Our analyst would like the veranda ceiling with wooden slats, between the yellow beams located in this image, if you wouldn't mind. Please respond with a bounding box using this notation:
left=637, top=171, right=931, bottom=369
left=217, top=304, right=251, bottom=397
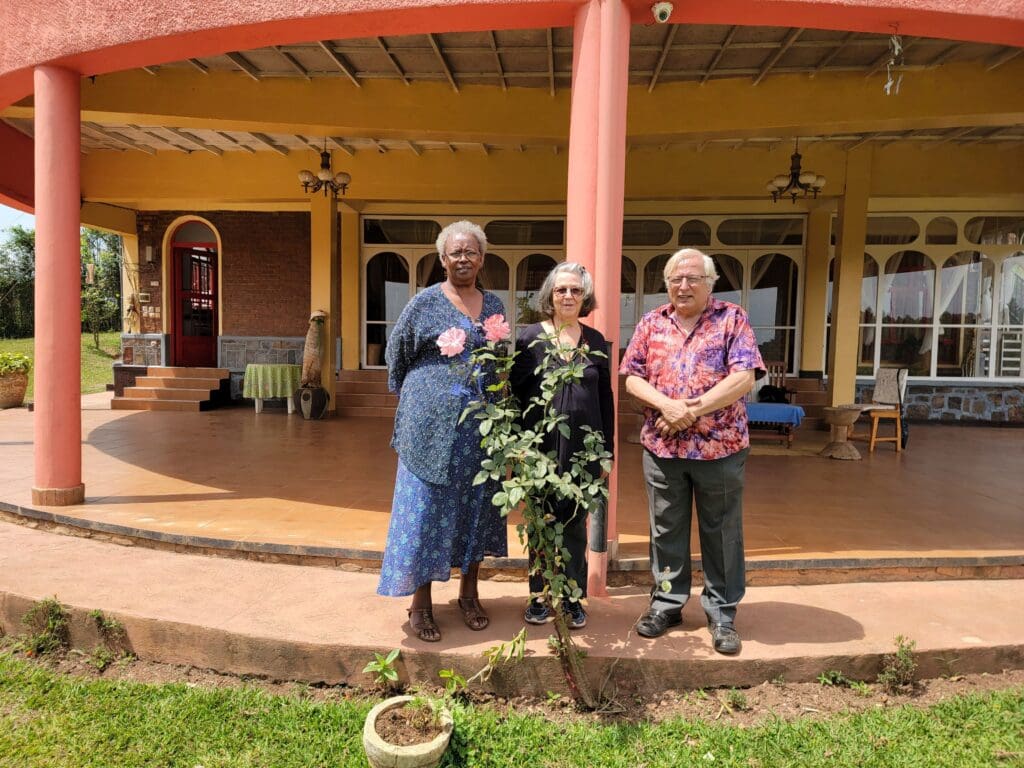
left=3, top=25, right=1024, bottom=156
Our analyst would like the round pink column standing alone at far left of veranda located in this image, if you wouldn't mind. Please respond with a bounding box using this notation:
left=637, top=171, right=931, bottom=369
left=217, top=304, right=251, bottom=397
left=32, top=67, right=85, bottom=505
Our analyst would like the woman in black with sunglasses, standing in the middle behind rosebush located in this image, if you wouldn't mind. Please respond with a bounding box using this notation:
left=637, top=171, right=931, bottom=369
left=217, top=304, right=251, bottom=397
left=511, top=261, right=615, bottom=629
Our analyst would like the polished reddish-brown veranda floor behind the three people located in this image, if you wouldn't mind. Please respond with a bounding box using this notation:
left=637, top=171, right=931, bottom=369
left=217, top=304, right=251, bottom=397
left=0, top=395, right=1024, bottom=563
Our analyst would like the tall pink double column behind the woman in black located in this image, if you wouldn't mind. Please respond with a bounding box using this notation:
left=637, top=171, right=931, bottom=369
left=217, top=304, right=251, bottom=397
left=566, top=0, right=630, bottom=597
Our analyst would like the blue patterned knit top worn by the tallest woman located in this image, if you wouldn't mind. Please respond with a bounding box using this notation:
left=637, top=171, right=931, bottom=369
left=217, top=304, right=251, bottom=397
left=384, top=285, right=505, bottom=484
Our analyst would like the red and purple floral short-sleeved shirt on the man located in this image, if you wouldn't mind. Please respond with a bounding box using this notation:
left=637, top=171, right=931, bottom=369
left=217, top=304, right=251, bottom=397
left=618, top=296, right=765, bottom=459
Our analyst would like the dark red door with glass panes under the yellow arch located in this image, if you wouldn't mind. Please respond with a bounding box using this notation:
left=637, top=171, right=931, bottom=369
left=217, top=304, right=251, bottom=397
left=172, top=244, right=217, bottom=368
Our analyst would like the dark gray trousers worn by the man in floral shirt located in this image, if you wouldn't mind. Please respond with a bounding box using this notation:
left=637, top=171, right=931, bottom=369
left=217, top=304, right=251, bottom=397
left=643, top=449, right=750, bottom=624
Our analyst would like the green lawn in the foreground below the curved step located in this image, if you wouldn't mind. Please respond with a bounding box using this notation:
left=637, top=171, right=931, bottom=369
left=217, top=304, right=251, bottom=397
left=0, top=653, right=1024, bottom=768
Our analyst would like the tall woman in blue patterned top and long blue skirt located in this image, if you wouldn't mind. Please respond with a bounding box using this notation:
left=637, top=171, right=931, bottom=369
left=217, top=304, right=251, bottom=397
left=377, top=221, right=508, bottom=642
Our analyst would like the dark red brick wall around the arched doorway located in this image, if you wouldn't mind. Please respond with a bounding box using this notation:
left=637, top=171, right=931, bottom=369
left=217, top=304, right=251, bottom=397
left=137, top=211, right=310, bottom=337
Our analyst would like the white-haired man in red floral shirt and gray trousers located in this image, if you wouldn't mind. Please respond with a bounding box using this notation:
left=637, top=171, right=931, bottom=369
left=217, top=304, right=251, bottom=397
left=620, top=249, right=764, bottom=653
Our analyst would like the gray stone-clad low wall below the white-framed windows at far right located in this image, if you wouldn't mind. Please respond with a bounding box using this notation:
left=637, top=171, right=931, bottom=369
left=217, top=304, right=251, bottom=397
left=857, top=382, right=1024, bottom=426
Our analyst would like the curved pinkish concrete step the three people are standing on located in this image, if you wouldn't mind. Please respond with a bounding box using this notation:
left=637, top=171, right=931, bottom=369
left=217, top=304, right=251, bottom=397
left=0, top=523, right=1024, bottom=697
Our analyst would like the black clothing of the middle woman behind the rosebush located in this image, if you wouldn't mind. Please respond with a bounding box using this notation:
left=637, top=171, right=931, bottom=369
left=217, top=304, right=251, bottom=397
left=510, top=323, right=615, bottom=596
